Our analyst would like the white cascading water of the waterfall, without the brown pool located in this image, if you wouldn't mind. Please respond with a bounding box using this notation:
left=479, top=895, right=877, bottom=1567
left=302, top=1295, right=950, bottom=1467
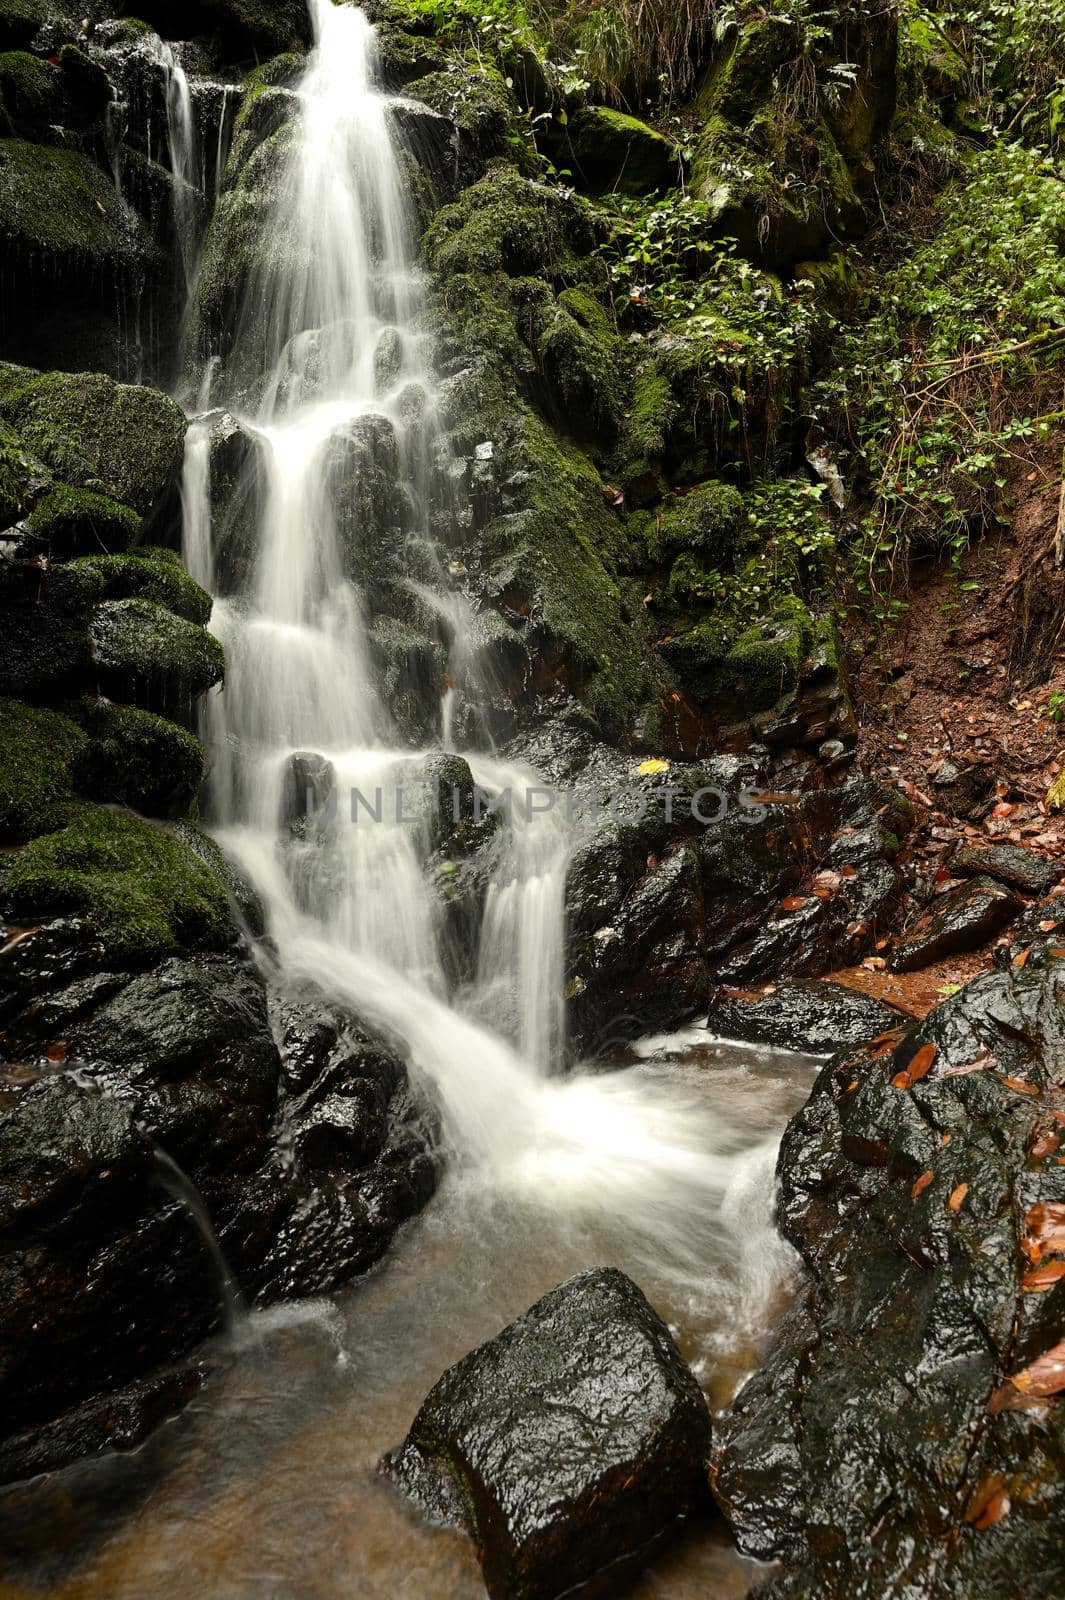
left=185, top=0, right=793, bottom=1376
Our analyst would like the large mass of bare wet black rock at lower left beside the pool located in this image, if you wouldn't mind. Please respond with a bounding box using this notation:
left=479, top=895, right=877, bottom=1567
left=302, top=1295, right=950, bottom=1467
left=0, top=918, right=437, bottom=1478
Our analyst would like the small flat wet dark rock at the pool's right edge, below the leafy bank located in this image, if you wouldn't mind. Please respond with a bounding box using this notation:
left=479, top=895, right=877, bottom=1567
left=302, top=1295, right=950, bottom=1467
left=708, top=982, right=913, bottom=1056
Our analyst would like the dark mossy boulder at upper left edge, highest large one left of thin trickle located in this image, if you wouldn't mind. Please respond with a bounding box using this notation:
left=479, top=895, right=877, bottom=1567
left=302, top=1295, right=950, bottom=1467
left=0, top=139, right=150, bottom=280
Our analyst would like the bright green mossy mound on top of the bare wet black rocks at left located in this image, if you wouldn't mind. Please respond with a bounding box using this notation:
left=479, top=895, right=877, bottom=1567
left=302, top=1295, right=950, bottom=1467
left=0, top=808, right=233, bottom=962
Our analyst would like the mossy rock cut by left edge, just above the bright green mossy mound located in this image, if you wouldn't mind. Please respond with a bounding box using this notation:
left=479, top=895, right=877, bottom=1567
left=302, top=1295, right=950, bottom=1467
left=0, top=699, right=86, bottom=845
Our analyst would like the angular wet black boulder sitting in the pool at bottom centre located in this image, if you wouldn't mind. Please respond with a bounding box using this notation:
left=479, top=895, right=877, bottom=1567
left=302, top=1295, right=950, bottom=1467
left=382, top=1269, right=710, bottom=1600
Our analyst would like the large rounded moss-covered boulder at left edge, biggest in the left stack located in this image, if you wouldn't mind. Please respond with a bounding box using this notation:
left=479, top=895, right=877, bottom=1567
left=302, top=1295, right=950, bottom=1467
left=0, top=363, right=187, bottom=515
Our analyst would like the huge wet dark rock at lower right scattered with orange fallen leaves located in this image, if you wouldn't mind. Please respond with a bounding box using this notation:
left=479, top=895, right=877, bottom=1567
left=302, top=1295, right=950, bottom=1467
left=712, top=960, right=1065, bottom=1600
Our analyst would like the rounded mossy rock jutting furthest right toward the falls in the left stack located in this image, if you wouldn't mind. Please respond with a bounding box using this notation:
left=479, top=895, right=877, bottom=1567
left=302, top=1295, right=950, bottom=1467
left=90, top=597, right=225, bottom=715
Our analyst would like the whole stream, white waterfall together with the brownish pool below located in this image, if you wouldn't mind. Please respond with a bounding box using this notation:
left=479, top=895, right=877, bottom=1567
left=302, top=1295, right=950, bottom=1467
left=3, top=0, right=811, bottom=1600
